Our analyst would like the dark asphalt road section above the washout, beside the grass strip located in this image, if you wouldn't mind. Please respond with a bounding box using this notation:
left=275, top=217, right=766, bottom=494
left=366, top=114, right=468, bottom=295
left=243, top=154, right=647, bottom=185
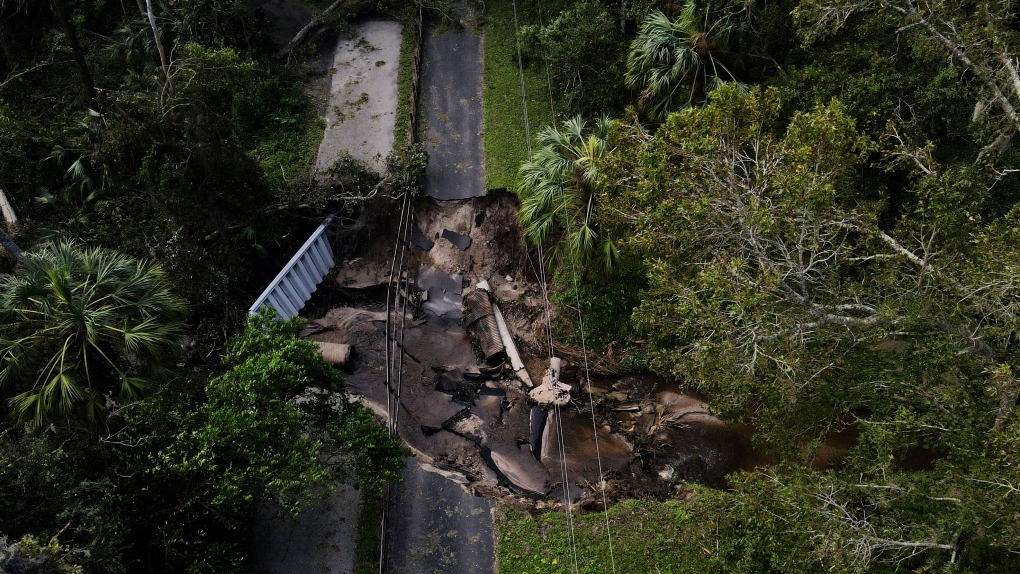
left=421, top=31, right=486, bottom=200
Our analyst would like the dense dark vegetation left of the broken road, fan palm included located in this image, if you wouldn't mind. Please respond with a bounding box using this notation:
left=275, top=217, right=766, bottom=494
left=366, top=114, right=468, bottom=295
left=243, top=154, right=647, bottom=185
left=0, top=0, right=408, bottom=572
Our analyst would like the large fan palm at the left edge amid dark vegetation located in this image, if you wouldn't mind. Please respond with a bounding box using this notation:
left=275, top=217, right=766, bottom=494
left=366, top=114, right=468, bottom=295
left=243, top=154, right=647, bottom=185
left=0, top=241, right=184, bottom=425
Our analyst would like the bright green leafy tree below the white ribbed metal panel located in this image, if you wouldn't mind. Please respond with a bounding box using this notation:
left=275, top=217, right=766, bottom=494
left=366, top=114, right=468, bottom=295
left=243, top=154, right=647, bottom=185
left=117, top=315, right=403, bottom=572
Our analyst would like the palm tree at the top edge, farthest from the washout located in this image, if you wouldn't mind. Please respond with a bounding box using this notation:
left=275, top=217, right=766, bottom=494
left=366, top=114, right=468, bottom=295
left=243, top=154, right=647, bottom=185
left=625, top=0, right=749, bottom=121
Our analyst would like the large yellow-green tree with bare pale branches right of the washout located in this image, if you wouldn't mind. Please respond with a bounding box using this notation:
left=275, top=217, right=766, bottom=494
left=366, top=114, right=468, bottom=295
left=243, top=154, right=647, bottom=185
left=597, top=87, right=1020, bottom=572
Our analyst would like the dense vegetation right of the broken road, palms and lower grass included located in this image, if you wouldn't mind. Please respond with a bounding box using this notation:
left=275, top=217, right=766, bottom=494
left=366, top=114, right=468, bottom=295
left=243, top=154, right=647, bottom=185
left=500, top=0, right=1020, bottom=573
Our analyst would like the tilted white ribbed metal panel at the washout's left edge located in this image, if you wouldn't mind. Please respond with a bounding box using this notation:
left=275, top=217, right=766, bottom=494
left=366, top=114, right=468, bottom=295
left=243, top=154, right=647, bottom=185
left=248, top=215, right=334, bottom=320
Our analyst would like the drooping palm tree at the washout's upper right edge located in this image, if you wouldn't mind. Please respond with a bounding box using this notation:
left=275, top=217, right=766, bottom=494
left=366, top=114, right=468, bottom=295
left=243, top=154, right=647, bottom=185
left=517, top=115, right=618, bottom=271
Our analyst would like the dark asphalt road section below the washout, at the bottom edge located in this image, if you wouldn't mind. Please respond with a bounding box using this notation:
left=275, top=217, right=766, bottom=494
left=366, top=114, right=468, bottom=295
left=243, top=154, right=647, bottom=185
left=388, top=459, right=496, bottom=574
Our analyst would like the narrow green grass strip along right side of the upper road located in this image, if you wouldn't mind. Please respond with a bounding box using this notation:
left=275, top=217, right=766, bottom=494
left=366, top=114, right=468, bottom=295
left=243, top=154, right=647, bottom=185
left=482, top=0, right=554, bottom=190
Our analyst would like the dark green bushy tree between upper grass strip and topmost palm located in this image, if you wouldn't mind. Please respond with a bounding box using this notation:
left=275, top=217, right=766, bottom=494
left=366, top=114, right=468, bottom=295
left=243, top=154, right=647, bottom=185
left=520, top=2, right=626, bottom=117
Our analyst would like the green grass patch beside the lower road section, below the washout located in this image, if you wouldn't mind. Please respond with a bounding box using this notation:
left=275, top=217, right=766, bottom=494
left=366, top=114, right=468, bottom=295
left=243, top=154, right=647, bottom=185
left=496, top=501, right=715, bottom=574
